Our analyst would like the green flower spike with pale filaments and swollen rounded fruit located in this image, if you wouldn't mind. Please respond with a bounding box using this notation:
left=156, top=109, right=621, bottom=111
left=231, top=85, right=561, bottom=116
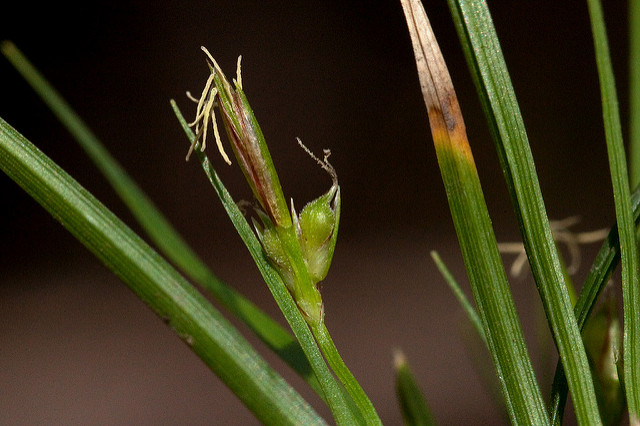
left=187, top=47, right=340, bottom=325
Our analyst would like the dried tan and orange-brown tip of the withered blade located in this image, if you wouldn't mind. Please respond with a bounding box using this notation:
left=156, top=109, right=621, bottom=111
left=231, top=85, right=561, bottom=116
left=401, top=0, right=473, bottom=163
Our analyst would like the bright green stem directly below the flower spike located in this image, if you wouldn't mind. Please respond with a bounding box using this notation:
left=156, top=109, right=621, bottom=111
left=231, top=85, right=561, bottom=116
left=312, top=322, right=382, bottom=425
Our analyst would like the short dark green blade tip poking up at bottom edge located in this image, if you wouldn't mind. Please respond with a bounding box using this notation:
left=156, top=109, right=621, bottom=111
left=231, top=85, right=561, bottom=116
left=393, top=351, right=436, bottom=426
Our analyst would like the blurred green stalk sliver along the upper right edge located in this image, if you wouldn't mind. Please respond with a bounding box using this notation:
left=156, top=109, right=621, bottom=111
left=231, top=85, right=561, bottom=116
left=629, top=0, right=640, bottom=188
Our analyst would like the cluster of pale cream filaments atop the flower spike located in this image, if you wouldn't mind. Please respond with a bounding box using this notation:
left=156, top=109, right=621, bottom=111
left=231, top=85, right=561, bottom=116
left=186, top=46, right=242, bottom=164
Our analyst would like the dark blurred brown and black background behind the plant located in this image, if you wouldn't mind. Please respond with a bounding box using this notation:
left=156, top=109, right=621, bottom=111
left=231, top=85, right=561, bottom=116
left=0, top=0, right=627, bottom=425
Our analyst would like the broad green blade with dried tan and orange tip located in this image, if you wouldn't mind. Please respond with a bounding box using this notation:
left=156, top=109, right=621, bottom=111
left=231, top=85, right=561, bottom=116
left=402, top=0, right=549, bottom=425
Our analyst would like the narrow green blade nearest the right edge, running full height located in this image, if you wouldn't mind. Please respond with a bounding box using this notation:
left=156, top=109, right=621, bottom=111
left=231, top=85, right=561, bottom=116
left=587, top=0, right=640, bottom=423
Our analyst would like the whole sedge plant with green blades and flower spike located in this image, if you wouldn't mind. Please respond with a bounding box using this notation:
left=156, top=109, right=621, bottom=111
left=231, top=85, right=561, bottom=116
left=0, top=0, right=640, bottom=425
